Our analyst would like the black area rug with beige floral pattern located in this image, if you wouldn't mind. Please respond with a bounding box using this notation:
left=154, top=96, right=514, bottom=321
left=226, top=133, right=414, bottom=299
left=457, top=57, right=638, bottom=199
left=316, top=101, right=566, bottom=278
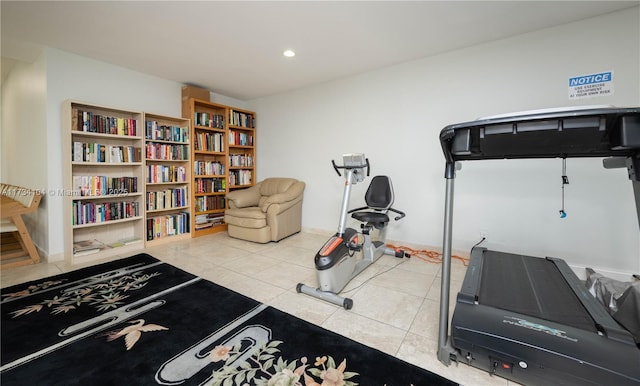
left=0, top=254, right=456, bottom=386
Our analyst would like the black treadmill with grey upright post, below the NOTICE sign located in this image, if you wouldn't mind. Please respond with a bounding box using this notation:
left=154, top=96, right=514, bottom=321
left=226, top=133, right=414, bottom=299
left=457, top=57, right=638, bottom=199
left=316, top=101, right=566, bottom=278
left=437, top=108, right=640, bottom=386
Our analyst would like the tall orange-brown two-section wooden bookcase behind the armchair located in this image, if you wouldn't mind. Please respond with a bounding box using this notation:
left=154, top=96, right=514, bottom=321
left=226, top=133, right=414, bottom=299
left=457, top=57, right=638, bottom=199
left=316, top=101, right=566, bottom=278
left=182, top=98, right=256, bottom=237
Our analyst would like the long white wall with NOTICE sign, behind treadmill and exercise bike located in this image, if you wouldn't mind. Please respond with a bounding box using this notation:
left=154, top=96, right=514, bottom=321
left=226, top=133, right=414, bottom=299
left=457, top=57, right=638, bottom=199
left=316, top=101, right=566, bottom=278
left=249, top=8, right=640, bottom=272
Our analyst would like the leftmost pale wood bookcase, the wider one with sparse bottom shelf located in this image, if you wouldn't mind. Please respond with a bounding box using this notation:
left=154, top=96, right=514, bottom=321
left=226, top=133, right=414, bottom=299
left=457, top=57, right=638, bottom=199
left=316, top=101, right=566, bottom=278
left=62, top=101, right=145, bottom=264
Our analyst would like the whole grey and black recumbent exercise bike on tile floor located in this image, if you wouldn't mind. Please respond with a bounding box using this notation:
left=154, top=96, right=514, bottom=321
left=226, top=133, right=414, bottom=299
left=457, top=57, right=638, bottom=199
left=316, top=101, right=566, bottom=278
left=296, top=154, right=409, bottom=310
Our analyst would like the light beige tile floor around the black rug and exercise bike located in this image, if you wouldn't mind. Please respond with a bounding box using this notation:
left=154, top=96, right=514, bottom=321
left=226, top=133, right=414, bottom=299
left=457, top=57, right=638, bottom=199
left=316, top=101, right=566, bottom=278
left=0, top=232, right=515, bottom=386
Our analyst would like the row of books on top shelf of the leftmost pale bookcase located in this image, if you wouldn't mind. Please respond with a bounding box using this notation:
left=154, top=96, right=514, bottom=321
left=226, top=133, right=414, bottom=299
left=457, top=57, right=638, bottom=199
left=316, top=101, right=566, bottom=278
left=71, top=109, right=138, bottom=137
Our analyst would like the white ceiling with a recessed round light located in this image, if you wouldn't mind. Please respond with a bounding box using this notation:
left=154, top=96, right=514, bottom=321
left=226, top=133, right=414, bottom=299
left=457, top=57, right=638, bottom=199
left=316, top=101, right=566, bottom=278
left=0, top=0, right=640, bottom=100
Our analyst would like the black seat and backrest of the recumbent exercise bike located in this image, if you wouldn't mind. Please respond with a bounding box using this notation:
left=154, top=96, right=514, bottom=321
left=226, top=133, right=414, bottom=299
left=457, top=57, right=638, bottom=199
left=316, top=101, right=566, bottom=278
left=349, top=176, right=394, bottom=229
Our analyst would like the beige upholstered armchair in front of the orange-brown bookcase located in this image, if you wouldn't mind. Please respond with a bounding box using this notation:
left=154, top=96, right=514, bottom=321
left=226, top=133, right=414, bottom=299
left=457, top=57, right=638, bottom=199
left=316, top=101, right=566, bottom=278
left=224, top=178, right=305, bottom=243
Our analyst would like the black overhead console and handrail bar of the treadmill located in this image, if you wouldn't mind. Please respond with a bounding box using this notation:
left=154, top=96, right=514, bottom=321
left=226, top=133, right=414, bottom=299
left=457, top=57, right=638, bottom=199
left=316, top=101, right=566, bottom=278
left=440, top=107, right=640, bottom=164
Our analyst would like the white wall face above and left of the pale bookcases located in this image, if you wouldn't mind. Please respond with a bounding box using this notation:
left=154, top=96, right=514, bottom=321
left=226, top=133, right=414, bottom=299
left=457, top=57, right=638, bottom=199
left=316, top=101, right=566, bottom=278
left=44, top=49, right=182, bottom=261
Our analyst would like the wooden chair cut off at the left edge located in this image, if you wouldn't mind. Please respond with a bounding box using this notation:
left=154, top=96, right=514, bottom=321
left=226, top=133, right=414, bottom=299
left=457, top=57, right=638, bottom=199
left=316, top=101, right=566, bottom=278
left=0, top=184, right=42, bottom=269
